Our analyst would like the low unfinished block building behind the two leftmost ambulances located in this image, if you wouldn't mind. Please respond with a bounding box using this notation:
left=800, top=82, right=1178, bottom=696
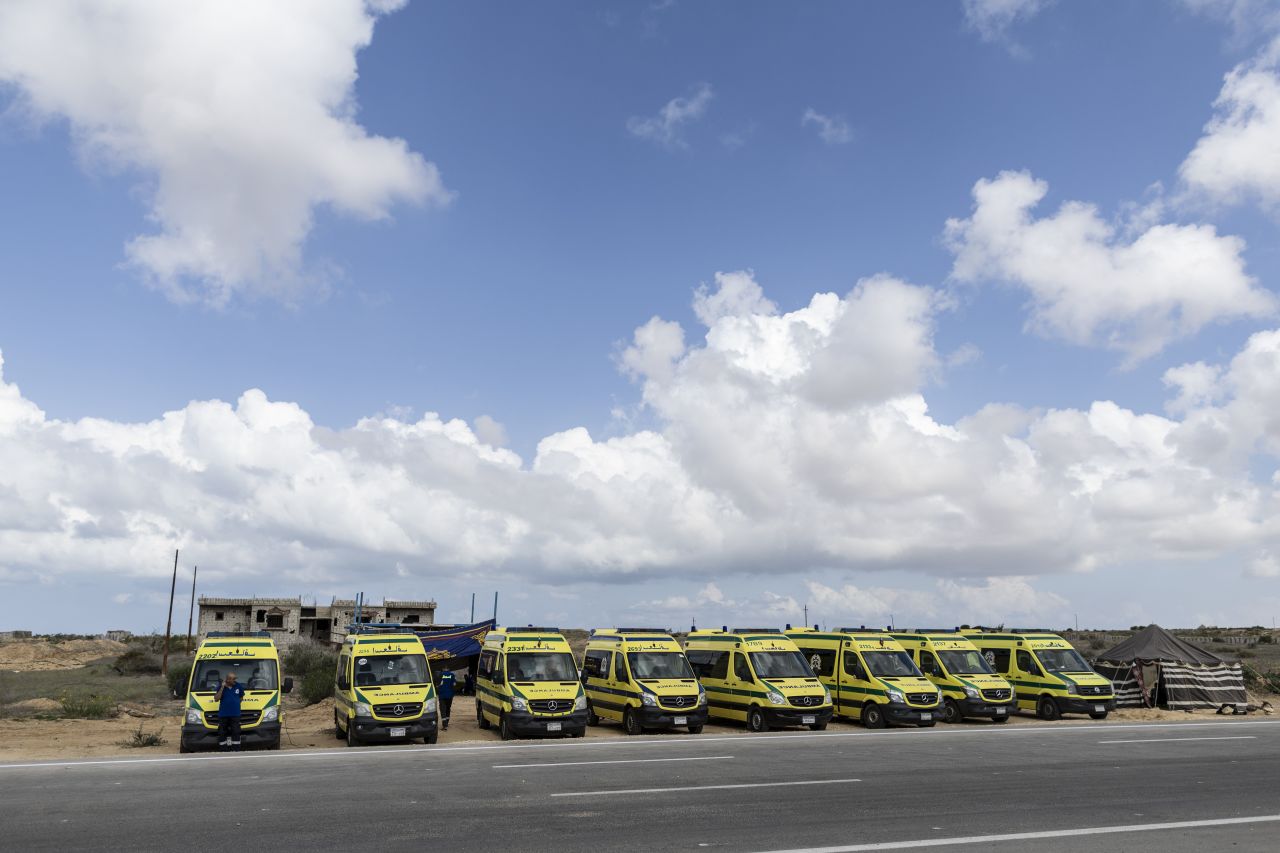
left=198, top=596, right=435, bottom=646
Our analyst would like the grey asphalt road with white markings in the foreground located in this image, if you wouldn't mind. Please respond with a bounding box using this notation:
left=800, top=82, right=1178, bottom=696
left=0, top=721, right=1280, bottom=853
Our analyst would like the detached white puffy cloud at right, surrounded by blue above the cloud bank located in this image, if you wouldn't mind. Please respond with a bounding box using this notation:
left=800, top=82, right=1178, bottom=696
left=946, top=172, right=1276, bottom=362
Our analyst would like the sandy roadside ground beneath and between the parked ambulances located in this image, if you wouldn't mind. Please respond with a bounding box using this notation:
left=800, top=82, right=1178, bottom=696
left=0, top=697, right=1275, bottom=763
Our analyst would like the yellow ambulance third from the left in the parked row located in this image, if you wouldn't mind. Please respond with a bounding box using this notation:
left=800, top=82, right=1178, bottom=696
left=476, top=626, right=586, bottom=740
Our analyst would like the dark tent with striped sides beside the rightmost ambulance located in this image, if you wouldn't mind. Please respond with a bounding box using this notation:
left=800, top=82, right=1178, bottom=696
left=1093, top=625, right=1248, bottom=711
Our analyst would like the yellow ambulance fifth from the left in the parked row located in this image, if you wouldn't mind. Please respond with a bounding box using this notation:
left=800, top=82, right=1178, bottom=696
left=685, top=628, right=832, bottom=731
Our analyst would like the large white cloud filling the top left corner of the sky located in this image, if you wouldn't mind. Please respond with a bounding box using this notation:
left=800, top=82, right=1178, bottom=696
left=0, top=0, right=451, bottom=305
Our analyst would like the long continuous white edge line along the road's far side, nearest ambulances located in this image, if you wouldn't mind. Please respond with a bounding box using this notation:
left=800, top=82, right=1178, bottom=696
left=0, top=720, right=1280, bottom=770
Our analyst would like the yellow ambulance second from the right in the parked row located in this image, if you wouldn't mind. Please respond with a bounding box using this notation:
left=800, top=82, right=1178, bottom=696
left=892, top=630, right=1014, bottom=722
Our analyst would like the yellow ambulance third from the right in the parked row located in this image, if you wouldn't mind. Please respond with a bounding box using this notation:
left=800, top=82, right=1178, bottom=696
left=787, top=628, right=942, bottom=729
